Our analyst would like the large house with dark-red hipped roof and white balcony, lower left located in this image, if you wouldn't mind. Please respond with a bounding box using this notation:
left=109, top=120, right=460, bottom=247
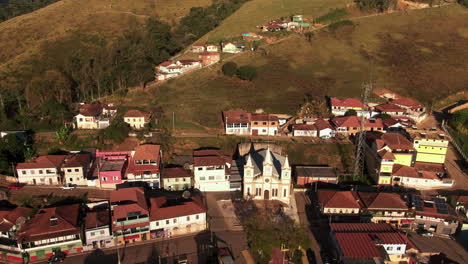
left=17, top=204, right=83, bottom=261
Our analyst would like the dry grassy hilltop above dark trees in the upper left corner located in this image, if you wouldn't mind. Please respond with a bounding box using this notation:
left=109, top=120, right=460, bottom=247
left=0, top=0, right=211, bottom=69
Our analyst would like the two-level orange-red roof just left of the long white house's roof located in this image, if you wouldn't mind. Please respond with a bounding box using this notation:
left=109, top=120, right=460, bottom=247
left=110, top=187, right=148, bottom=220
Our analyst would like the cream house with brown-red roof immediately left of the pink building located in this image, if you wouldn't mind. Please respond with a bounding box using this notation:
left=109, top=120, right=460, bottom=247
left=61, top=153, right=92, bottom=186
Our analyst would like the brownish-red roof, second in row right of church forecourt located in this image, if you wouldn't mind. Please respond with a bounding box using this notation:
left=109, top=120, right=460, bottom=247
left=358, top=192, right=408, bottom=211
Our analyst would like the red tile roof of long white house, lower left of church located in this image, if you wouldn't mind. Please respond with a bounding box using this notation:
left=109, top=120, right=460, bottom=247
left=150, top=196, right=206, bottom=221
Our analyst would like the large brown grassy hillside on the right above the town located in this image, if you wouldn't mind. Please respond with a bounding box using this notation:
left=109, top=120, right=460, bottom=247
left=134, top=5, right=468, bottom=128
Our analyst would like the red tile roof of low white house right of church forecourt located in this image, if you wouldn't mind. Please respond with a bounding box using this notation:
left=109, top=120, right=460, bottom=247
left=318, top=190, right=362, bottom=209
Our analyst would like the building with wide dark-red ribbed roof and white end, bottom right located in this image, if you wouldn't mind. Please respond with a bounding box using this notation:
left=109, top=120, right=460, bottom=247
left=330, top=223, right=411, bottom=264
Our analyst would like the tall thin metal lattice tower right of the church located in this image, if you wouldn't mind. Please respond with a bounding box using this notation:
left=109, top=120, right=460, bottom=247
left=353, top=83, right=372, bottom=180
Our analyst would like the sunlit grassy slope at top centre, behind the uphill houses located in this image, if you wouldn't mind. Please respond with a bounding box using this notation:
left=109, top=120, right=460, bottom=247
left=202, top=0, right=353, bottom=40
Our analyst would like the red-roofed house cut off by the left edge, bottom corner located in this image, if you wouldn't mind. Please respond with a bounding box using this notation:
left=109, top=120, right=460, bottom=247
left=0, top=207, right=32, bottom=263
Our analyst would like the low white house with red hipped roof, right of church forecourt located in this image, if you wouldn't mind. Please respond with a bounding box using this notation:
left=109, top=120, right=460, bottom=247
left=317, top=190, right=364, bottom=218
